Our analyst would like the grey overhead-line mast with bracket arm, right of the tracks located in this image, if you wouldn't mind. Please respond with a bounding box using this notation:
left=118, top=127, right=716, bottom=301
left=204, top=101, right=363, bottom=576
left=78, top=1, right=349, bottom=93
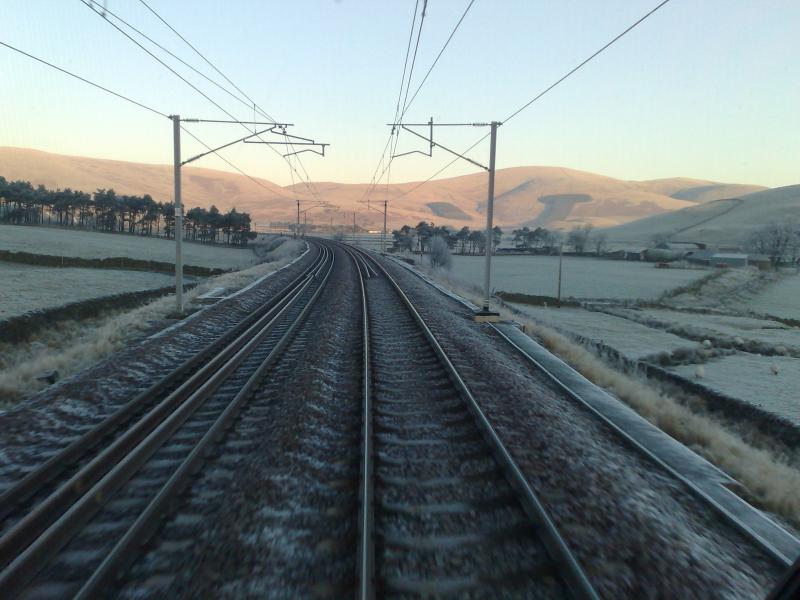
left=384, top=117, right=502, bottom=323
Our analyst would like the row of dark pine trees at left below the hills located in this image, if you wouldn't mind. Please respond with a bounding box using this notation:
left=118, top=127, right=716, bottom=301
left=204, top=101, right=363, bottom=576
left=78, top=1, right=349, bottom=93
left=0, top=176, right=256, bottom=246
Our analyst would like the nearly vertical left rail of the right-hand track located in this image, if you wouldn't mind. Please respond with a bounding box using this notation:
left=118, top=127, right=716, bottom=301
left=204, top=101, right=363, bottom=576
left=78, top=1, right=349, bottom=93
left=345, top=247, right=375, bottom=600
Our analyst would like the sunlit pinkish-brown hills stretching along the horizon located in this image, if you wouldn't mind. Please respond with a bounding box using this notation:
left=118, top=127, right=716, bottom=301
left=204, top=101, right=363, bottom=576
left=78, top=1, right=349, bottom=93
left=0, top=147, right=766, bottom=229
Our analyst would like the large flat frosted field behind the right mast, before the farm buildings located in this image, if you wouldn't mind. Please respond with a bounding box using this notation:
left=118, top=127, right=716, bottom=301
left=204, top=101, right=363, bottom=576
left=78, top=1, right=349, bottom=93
left=452, top=256, right=708, bottom=300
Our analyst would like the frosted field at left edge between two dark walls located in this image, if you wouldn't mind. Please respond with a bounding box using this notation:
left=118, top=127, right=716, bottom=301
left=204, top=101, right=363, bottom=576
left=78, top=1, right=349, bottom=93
left=0, top=262, right=181, bottom=322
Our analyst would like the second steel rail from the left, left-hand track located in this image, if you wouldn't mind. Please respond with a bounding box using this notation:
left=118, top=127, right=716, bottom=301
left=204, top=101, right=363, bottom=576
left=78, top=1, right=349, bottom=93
left=0, top=247, right=320, bottom=567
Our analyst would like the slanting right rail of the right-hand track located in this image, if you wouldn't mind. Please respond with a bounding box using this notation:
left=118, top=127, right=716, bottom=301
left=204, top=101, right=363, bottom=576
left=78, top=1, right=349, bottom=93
left=356, top=249, right=599, bottom=600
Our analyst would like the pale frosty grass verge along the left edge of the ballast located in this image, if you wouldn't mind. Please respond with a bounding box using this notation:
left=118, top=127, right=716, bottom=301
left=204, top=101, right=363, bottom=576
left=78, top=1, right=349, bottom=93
left=0, top=240, right=306, bottom=408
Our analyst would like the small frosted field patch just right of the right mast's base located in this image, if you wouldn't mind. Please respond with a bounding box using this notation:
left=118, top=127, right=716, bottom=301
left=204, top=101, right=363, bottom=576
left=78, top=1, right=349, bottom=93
left=513, top=304, right=697, bottom=360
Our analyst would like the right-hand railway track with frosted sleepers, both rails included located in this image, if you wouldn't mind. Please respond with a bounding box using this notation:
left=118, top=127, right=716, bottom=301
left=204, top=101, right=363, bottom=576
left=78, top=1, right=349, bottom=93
left=349, top=249, right=597, bottom=600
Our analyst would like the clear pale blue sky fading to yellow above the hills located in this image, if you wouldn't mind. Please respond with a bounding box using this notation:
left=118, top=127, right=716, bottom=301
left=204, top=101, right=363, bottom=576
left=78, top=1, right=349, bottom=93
left=0, top=0, right=800, bottom=187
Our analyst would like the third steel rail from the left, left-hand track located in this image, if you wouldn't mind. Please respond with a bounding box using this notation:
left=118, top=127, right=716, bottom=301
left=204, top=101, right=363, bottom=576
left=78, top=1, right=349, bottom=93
left=0, top=249, right=330, bottom=592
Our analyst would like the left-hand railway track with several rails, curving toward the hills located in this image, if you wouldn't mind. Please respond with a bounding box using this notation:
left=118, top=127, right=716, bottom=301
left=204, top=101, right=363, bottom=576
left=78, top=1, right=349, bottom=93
left=0, top=245, right=334, bottom=598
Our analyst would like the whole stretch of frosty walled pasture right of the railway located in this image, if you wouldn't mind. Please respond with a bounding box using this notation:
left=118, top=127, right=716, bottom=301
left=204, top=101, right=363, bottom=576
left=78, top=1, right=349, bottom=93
left=437, top=256, right=800, bottom=426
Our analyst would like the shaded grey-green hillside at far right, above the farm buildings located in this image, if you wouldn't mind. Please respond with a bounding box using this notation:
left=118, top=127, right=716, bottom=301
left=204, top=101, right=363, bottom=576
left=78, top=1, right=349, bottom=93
left=606, top=185, right=800, bottom=245
